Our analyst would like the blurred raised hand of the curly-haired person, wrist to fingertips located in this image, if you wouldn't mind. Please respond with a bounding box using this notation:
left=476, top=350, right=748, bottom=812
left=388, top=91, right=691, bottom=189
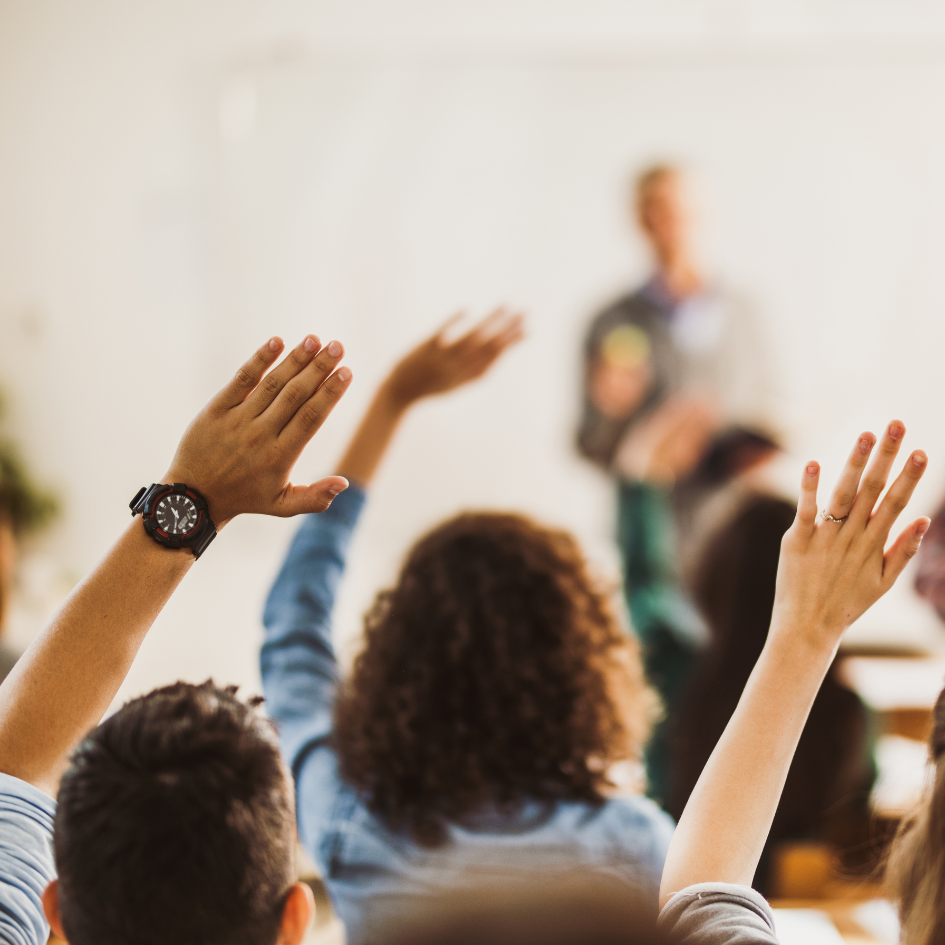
left=385, top=308, right=524, bottom=407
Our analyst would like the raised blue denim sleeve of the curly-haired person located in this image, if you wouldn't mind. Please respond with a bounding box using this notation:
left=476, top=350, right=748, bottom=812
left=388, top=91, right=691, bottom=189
left=260, top=484, right=366, bottom=862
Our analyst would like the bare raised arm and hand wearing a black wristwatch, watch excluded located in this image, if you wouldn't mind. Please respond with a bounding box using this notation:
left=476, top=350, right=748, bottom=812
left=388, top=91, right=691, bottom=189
left=0, top=335, right=351, bottom=794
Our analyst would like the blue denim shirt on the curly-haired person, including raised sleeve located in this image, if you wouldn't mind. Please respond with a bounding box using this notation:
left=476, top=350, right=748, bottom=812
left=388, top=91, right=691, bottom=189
left=261, top=485, right=673, bottom=945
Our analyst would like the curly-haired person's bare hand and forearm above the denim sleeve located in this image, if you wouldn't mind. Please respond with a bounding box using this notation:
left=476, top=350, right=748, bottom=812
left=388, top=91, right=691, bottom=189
left=338, top=308, right=523, bottom=486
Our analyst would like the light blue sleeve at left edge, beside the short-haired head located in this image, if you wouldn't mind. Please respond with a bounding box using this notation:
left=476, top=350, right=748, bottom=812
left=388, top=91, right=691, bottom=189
left=0, top=774, right=56, bottom=945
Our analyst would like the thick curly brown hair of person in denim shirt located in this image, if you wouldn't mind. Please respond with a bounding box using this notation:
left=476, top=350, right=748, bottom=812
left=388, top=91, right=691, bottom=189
left=335, top=513, right=655, bottom=846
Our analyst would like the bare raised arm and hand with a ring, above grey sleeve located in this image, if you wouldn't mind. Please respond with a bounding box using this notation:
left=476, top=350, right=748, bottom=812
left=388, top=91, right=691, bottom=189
left=660, top=422, right=929, bottom=904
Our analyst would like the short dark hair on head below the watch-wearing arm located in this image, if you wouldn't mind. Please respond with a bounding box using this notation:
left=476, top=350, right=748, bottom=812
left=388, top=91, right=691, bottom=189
left=54, top=680, right=295, bottom=945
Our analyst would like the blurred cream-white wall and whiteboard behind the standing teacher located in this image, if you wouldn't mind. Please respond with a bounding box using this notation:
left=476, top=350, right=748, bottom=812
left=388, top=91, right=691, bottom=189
left=0, top=0, right=945, bottom=699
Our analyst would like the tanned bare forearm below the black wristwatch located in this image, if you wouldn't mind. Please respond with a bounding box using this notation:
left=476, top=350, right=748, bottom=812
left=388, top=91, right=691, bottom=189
left=0, top=521, right=194, bottom=794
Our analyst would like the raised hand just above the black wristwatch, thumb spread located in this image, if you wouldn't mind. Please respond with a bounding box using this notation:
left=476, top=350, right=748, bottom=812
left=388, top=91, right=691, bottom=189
left=162, top=335, right=351, bottom=528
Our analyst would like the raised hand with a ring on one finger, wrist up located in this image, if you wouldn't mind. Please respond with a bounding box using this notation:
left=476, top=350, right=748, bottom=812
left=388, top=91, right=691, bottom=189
left=771, top=420, right=930, bottom=648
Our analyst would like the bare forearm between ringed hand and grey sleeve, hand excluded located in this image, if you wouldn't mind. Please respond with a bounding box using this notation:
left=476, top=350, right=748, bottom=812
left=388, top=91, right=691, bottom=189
left=660, top=628, right=834, bottom=905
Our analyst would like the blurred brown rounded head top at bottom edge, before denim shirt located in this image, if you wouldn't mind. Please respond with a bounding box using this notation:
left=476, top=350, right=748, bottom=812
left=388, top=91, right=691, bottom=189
left=383, top=875, right=669, bottom=945
